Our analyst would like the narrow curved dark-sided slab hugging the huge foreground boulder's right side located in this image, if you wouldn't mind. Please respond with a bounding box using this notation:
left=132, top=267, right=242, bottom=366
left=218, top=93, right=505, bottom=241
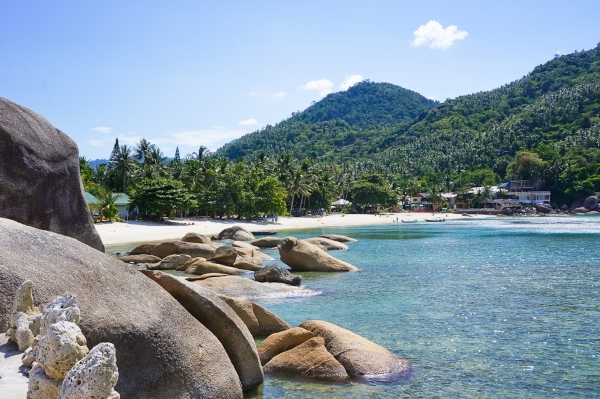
left=142, top=271, right=263, bottom=390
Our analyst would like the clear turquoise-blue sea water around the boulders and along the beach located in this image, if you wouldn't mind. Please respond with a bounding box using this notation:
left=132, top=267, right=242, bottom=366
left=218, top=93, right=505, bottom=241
left=110, top=216, right=600, bottom=399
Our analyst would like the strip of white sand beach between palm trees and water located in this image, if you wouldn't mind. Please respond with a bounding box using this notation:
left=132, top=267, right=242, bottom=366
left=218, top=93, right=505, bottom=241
left=96, top=213, right=490, bottom=245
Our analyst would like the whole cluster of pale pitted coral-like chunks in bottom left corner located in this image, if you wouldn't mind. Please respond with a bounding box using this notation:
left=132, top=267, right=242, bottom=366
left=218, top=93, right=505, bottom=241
left=8, top=280, right=120, bottom=399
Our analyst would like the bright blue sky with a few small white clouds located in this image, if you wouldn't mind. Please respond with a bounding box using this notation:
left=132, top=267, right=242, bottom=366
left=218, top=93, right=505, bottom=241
left=0, top=0, right=600, bottom=160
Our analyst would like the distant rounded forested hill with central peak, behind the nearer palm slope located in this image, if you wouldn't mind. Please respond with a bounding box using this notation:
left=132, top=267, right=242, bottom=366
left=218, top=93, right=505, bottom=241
left=217, top=81, right=438, bottom=159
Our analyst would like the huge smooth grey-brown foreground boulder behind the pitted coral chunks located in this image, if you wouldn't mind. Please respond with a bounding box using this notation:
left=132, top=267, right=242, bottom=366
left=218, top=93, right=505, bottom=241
left=0, top=219, right=242, bottom=398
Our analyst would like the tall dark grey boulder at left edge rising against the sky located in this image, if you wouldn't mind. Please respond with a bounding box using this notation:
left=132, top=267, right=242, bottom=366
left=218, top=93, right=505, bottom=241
left=0, top=97, right=104, bottom=252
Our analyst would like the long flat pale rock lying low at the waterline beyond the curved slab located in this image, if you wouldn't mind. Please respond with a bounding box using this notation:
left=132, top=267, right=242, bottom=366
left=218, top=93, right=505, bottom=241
left=194, top=276, right=317, bottom=300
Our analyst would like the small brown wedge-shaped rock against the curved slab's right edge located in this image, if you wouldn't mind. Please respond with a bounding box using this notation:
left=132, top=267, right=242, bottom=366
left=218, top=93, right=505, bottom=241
left=220, top=295, right=290, bottom=336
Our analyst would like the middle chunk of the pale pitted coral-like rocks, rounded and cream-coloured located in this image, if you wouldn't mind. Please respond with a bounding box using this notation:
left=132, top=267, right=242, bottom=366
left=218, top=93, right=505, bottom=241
left=35, top=321, right=89, bottom=381
